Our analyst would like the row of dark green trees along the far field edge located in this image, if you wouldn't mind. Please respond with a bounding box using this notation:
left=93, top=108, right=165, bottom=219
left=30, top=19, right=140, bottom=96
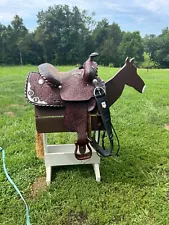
left=0, top=5, right=169, bottom=68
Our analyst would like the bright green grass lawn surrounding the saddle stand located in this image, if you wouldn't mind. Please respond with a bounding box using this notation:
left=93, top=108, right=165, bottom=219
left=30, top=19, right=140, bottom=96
left=0, top=66, right=169, bottom=225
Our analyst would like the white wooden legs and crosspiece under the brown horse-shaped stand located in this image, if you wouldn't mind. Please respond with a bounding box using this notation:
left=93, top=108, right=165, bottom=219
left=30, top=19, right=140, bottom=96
left=43, top=133, right=100, bottom=185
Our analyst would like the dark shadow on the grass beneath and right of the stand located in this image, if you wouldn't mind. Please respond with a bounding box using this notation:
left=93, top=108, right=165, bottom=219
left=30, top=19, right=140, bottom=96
left=48, top=146, right=161, bottom=186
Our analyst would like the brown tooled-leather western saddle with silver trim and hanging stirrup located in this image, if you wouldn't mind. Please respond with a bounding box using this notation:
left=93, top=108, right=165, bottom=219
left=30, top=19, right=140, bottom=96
left=25, top=53, right=109, bottom=160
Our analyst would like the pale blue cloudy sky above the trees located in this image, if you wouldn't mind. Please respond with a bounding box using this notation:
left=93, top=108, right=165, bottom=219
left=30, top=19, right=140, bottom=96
left=0, top=0, right=169, bottom=37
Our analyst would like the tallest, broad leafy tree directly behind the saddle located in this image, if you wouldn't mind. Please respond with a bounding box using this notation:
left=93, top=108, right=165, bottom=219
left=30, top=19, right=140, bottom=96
left=35, top=5, right=92, bottom=64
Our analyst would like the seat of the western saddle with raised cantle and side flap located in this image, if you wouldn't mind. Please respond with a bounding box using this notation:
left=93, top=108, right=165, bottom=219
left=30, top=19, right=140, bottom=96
left=38, top=63, right=94, bottom=101
